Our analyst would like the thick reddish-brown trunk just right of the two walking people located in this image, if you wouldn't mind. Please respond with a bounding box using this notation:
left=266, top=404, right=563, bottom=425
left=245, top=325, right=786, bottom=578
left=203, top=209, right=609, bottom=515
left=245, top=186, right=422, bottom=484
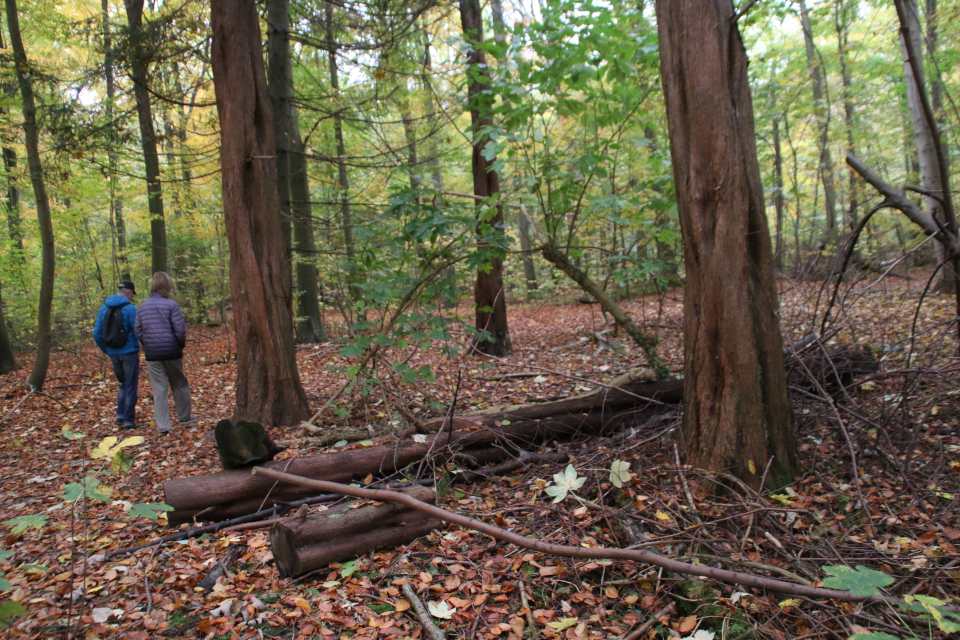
left=210, top=0, right=310, bottom=426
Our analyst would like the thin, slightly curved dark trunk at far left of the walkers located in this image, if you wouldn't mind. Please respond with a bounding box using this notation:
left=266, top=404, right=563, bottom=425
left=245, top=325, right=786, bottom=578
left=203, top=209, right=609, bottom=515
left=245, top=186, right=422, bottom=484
left=5, top=0, right=56, bottom=389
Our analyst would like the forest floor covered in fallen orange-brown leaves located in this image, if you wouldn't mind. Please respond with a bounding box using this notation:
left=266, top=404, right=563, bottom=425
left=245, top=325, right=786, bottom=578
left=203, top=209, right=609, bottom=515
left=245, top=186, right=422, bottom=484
left=0, top=276, right=960, bottom=640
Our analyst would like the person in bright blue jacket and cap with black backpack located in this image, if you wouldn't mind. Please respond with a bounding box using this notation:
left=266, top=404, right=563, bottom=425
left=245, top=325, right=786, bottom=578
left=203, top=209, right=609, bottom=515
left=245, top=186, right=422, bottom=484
left=93, top=280, right=140, bottom=429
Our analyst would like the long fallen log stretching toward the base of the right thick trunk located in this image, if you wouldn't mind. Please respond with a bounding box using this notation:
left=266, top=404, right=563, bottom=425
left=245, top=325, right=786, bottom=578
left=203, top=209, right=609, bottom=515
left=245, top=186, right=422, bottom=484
left=163, top=381, right=683, bottom=526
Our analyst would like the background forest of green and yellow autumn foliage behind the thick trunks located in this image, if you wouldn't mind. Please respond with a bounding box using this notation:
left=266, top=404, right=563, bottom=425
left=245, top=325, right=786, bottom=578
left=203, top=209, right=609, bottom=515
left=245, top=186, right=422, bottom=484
left=0, top=0, right=958, bottom=350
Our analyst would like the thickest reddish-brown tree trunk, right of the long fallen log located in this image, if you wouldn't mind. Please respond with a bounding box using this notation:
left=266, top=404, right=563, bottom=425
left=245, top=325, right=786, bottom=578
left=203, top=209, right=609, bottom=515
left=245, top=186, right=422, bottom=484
left=656, top=0, right=796, bottom=487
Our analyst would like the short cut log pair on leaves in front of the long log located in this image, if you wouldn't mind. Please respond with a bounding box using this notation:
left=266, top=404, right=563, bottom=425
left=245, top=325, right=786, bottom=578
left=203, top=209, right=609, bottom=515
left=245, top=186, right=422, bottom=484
left=270, top=486, right=440, bottom=577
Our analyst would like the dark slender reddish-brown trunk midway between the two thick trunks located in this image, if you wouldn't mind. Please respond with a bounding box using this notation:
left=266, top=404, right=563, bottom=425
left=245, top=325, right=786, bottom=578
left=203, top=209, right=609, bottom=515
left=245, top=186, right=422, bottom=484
left=460, top=0, right=513, bottom=356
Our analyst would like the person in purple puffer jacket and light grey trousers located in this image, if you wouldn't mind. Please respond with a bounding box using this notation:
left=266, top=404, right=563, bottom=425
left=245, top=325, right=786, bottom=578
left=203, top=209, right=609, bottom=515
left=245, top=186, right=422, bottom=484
left=134, top=271, right=197, bottom=435
